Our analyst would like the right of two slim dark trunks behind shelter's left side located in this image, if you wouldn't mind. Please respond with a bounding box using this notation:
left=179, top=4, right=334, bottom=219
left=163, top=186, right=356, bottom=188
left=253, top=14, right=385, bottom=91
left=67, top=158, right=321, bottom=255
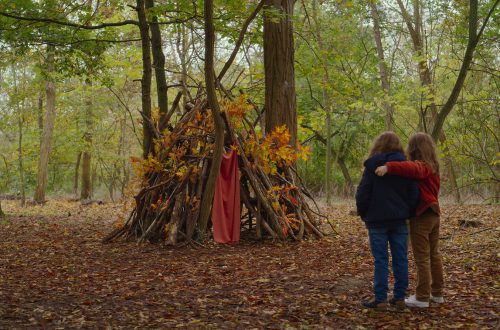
left=146, top=0, right=168, bottom=120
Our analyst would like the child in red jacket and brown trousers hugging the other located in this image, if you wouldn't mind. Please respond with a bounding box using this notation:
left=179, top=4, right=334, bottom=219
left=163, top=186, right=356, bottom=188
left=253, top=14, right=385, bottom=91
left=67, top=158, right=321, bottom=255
left=375, top=133, right=444, bottom=308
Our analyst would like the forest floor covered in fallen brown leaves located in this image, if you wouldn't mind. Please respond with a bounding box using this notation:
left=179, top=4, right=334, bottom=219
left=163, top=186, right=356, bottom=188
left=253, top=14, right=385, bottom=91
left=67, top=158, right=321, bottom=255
left=0, top=200, right=500, bottom=329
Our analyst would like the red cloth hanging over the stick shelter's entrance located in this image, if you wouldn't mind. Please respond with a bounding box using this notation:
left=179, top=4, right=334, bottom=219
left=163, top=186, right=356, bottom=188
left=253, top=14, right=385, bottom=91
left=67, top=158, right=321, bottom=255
left=212, top=149, right=240, bottom=244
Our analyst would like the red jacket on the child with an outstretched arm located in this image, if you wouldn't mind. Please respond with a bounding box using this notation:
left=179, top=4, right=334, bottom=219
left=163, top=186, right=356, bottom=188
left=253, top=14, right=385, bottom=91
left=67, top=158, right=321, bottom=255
left=385, top=160, right=440, bottom=216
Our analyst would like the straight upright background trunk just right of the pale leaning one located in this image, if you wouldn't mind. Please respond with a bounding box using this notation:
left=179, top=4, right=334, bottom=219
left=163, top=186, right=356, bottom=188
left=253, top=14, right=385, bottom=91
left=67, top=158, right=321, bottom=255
left=80, top=81, right=93, bottom=200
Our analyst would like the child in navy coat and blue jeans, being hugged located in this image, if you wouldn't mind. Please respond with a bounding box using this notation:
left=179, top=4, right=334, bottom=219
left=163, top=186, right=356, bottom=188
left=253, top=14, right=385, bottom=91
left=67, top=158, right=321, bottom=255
left=356, top=132, right=419, bottom=309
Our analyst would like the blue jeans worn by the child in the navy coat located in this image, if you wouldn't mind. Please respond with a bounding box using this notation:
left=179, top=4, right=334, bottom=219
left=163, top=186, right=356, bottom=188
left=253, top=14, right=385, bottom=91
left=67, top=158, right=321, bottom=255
left=368, top=224, right=408, bottom=301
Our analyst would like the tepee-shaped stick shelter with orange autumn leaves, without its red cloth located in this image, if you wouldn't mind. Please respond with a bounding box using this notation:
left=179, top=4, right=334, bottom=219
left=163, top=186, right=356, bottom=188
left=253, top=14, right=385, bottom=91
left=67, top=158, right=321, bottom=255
left=103, top=95, right=325, bottom=245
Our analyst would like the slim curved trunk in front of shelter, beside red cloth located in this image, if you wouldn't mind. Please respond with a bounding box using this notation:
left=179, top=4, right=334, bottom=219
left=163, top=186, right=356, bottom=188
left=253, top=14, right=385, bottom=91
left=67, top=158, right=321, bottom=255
left=199, top=0, right=224, bottom=236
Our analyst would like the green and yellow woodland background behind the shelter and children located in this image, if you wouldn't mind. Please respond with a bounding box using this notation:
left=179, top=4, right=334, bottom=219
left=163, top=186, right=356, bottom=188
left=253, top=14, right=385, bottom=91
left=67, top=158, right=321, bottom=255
left=0, top=0, right=500, bottom=203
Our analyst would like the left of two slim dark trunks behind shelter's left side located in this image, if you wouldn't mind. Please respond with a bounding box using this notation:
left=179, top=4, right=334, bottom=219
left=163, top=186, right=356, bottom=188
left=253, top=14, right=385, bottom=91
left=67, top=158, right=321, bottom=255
left=137, top=0, right=153, bottom=158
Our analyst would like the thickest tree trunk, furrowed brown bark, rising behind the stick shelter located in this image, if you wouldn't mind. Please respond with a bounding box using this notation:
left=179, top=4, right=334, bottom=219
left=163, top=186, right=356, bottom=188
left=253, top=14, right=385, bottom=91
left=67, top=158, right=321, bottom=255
left=264, top=0, right=297, bottom=145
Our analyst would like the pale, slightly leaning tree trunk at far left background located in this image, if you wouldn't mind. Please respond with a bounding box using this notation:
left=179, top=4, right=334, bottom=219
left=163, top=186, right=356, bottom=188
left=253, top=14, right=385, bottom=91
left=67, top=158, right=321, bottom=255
left=34, top=46, right=56, bottom=203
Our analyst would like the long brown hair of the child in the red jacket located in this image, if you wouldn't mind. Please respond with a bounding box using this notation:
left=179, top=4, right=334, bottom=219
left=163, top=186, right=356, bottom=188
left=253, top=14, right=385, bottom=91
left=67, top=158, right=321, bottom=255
left=406, top=132, right=439, bottom=173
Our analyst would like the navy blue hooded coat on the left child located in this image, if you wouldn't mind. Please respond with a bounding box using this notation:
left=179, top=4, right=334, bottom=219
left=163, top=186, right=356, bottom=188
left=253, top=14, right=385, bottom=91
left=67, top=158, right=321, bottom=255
left=356, top=152, right=420, bottom=228
